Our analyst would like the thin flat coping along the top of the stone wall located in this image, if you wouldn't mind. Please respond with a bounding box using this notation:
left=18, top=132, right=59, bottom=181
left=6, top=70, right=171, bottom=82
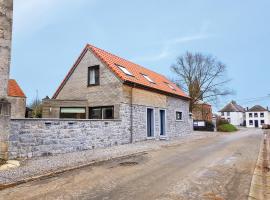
left=10, top=118, right=122, bottom=122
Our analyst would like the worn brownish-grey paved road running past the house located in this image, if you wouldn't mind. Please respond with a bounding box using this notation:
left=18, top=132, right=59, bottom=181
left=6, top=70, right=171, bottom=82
left=0, top=129, right=262, bottom=200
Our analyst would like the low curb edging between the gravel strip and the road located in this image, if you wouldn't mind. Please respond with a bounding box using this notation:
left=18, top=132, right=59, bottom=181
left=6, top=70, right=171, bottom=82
left=0, top=150, right=147, bottom=191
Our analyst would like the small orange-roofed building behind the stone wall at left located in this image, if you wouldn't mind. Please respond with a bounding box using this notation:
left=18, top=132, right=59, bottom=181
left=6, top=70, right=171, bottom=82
left=8, top=79, right=26, bottom=118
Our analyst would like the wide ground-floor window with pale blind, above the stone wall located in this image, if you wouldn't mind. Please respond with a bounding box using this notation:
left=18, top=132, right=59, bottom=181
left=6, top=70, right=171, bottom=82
left=60, top=107, right=86, bottom=119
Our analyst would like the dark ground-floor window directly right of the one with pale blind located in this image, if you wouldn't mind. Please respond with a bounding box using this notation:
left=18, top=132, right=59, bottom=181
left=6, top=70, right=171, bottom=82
left=89, top=106, right=114, bottom=119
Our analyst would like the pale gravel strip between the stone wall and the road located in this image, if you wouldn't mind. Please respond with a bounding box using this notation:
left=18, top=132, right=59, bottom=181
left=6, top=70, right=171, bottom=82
left=0, top=131, right=218, bottom=185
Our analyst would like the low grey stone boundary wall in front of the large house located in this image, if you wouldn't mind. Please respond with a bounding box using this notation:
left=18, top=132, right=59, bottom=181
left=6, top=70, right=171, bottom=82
left=9, top=119, right=130, bottom=159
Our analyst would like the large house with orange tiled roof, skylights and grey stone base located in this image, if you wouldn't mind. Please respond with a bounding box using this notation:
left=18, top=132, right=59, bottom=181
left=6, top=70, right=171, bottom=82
left=42, top=44, right=192, bottom=141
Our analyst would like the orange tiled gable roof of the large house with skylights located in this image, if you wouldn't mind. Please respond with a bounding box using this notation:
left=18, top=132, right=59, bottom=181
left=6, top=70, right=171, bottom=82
left=52, top=44, right=189, bottom=99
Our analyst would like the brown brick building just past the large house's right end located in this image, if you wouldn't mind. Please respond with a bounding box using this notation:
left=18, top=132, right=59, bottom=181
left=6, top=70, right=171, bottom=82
left=192, top=101, right=213, bottom=121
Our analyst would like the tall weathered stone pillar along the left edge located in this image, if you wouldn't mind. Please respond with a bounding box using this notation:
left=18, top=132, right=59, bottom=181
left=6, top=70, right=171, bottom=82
left=0, top=0, right=13, bottom=160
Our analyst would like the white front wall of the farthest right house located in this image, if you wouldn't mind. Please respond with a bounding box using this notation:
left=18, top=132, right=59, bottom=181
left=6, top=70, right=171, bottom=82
left=246, top=111, right=270, bottom=128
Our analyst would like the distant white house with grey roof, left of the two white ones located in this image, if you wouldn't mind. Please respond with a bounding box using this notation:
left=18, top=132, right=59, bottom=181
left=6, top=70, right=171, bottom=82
left=219, top=101, right=245, bottom=126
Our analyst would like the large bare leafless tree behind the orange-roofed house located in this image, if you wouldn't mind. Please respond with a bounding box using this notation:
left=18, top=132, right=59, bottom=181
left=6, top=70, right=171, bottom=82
left=171, top=52, right=232, bottom=112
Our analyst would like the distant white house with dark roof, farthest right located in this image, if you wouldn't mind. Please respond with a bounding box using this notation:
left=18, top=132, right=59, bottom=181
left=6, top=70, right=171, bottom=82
left=246, top=105, right=270, bottom=128
